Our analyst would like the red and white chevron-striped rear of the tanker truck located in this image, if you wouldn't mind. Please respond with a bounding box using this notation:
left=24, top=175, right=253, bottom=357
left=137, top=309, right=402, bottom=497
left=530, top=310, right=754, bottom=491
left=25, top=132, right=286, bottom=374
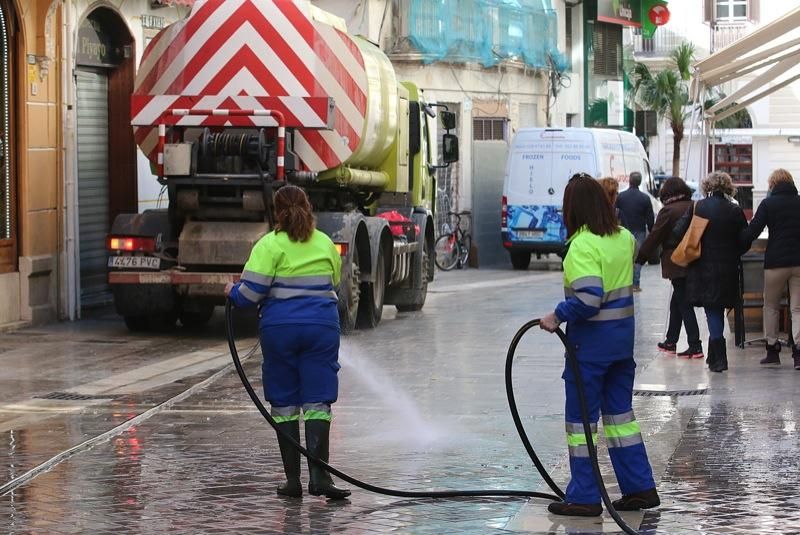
left=131, top=0, right=368, bottom=171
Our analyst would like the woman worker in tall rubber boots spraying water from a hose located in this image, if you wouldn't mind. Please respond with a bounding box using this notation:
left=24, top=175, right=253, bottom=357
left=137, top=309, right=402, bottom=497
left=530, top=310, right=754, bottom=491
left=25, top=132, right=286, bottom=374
left=226, top=186, right=350, bottom=499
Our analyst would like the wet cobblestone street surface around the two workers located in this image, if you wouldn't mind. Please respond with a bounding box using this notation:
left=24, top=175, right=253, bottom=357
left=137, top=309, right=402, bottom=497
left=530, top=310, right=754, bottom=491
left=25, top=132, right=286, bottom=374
left=0, top=267, right=800, bottom=534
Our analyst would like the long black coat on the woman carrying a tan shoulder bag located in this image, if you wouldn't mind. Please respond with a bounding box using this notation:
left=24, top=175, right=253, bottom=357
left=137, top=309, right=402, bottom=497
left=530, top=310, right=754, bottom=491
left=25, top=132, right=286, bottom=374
left=686, top=193, right=749, bottom=308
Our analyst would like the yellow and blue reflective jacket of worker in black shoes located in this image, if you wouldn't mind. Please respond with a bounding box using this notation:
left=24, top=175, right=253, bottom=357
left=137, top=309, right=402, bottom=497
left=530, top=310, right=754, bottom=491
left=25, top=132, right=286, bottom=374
left=556, top=227, right=635, bottom=361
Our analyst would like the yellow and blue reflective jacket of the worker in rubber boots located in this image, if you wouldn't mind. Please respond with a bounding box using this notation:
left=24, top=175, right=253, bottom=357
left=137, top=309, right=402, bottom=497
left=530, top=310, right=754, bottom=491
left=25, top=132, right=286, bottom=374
left=230, top=230, right=342, bottom=327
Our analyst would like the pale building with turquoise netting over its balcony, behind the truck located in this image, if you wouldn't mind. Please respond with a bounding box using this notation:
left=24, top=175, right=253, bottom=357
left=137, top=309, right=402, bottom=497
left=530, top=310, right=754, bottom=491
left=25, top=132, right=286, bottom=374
left=313, top=0, right=584, bottom=265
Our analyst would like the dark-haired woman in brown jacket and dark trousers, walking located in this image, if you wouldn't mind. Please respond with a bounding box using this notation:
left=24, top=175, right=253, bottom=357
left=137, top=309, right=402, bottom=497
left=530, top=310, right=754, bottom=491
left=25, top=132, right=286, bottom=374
left=636, top=177, right=704, bottom=358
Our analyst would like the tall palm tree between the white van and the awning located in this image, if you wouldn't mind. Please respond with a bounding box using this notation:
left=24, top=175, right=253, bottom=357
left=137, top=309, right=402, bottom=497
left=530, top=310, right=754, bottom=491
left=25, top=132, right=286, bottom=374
left=631, top=43, right=694, bottom=176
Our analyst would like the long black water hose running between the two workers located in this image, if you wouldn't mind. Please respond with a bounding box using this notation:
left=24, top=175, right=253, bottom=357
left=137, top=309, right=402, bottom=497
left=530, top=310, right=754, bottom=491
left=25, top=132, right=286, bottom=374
left=225, top=299, right=638, bottom=535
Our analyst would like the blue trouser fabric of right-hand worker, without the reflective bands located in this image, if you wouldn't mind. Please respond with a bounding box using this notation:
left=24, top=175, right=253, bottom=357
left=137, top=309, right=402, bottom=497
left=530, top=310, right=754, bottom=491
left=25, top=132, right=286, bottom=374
left=562, top=358, right=656, bottom=504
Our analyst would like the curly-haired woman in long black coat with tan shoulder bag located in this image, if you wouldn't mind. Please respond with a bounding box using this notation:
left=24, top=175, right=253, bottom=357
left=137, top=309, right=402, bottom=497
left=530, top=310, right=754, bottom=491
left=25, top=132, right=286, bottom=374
left=675, top=171, right=747, bottom=372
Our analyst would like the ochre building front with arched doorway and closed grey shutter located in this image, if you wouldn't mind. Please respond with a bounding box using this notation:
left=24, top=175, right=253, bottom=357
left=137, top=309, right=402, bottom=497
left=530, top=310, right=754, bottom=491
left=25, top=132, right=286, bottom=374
left=0, top=0, right=188, bottom=326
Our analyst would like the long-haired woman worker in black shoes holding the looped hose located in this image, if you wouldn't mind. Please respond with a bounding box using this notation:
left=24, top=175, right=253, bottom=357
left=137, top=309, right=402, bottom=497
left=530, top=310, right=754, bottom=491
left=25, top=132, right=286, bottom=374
left=540, top=173, right=661, bottom=516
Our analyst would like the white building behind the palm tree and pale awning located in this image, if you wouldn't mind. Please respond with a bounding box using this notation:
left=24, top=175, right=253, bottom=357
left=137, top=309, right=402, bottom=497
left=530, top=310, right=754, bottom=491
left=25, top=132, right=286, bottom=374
left=634, top=0, right=800, bottom=217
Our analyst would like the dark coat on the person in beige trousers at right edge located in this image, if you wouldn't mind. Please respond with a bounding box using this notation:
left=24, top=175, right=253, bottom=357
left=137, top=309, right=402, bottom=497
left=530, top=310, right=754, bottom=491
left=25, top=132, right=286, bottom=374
left=742, top=182, right=800, bottom=269
